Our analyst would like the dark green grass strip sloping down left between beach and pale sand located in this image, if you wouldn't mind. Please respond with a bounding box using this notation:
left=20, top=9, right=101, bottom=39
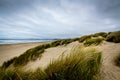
left=2, top=44, right=47, bottom=68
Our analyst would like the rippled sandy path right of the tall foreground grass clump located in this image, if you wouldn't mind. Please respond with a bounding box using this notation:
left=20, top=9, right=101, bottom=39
left=100, top=42, right=120, bottom=80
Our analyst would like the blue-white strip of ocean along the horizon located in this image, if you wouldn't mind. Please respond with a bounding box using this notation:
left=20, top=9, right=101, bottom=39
left=0, top=39, right=52, bottom=44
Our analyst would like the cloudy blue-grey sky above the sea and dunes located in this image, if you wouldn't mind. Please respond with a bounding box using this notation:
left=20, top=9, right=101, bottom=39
left=0, top=0, right=120, bottom=39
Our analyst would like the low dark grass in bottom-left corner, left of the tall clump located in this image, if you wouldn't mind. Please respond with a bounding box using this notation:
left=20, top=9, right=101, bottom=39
left=0, top=69, right=48, bottom=80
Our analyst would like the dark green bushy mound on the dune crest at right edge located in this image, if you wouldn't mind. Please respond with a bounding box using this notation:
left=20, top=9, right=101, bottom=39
left=106, top=31, right=120, bottom=43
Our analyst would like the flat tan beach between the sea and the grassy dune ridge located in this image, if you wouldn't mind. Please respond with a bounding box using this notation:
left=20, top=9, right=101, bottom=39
left=0, top=42, right=50, bottom=66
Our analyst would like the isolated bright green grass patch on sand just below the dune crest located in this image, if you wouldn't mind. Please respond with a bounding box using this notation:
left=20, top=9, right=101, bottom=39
left=84, top=37, right=104, bottom=46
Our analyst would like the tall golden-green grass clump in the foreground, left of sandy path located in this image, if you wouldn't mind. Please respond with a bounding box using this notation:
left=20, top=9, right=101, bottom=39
left=45, top=48, right=101, bottom=80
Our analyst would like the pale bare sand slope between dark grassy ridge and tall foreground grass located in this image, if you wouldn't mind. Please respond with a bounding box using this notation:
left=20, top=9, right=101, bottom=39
left=24, top=42, right=80, bottom=70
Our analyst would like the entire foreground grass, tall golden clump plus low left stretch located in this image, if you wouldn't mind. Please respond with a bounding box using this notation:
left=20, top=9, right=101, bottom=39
left=0, top=48, right=102, bottom=80
